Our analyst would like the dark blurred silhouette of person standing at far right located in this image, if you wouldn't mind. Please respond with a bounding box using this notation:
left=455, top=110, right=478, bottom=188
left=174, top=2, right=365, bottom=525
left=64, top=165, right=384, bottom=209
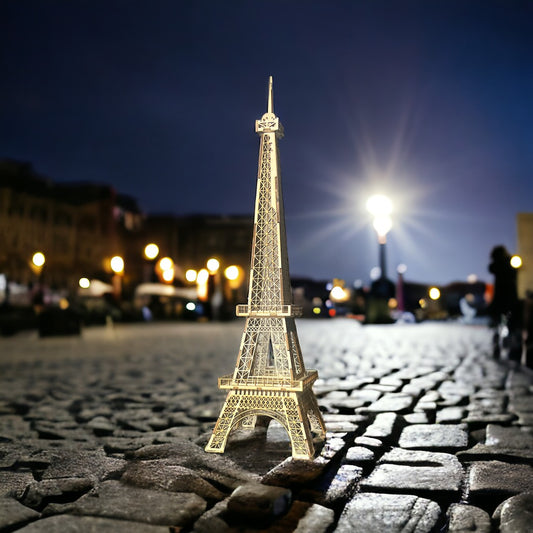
left=488, top=246, right=521, bottom=360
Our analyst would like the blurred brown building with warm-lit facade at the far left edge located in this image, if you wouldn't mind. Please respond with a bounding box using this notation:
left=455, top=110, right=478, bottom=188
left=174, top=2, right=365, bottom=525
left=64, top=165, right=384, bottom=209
left=0, top=160, right=139, bottom=288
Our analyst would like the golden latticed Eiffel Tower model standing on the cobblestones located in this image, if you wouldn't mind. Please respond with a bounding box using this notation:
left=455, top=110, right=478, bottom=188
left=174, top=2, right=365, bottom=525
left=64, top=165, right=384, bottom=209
left=206, top=76, right=326, bottom=459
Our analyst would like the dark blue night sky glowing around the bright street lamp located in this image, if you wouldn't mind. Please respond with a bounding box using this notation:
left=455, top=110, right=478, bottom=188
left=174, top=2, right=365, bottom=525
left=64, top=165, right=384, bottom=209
left=0, top=0, right=533, bottom=284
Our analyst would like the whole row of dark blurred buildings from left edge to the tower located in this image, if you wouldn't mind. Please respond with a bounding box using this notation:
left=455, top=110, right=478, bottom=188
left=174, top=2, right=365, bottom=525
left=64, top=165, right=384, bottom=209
left=0, top=160, right=253, bottom=304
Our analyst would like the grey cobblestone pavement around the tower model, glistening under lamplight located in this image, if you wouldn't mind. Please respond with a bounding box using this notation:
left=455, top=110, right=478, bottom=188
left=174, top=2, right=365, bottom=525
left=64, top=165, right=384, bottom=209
left=0, top=319, right=533, bottom=533
